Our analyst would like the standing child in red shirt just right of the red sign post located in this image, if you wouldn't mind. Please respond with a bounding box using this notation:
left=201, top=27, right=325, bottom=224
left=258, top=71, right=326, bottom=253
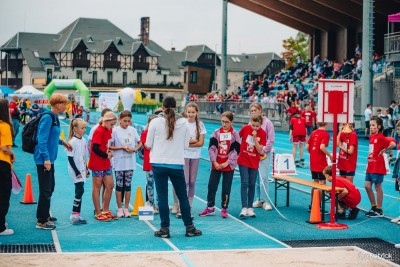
left=337, top=123, right=358, bottom=183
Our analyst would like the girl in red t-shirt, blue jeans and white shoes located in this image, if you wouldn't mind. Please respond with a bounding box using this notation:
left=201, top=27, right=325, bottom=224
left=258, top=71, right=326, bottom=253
left=237, top=114, right=267, bottom=217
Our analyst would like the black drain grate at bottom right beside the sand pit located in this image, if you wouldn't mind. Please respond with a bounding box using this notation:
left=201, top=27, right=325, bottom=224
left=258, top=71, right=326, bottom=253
left=282, top=238, right=400, bottom=264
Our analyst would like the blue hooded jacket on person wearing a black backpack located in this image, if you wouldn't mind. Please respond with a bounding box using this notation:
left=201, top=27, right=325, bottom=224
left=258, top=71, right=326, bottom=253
left=33, top=110, right=62, bottom=165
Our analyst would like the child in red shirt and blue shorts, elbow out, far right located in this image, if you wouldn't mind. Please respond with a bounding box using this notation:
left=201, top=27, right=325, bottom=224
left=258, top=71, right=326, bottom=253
left=365, top=116, right=396, bottom=217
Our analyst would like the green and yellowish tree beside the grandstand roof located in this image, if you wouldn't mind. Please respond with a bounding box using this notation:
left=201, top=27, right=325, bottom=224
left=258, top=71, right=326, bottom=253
left=282, top=32, right=310, bottom=68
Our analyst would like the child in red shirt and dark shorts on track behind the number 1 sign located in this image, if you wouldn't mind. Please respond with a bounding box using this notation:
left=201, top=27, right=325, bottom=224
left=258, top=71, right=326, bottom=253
left=289, top=112, right=307, bottom=168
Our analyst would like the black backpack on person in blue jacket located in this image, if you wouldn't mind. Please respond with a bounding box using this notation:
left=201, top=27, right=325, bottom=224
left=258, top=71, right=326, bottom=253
left=22, top=112, right=56, bottom=154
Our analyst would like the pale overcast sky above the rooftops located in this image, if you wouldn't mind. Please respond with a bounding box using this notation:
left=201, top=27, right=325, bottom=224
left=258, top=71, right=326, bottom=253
left=0, top=0, right=297, bottom=55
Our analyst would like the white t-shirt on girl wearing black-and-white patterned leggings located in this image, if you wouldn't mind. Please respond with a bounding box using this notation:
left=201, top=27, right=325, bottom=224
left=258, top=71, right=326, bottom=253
left=111, top=126, right=140, bottom=171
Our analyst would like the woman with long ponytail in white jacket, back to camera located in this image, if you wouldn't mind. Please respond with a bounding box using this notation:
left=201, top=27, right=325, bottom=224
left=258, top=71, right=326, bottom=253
left=146, top=97, right=202, bottom=238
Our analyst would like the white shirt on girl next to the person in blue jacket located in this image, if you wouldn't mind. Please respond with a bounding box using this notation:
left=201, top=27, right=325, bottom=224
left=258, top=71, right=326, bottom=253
left=67, top=136, right=88, bottom=183
